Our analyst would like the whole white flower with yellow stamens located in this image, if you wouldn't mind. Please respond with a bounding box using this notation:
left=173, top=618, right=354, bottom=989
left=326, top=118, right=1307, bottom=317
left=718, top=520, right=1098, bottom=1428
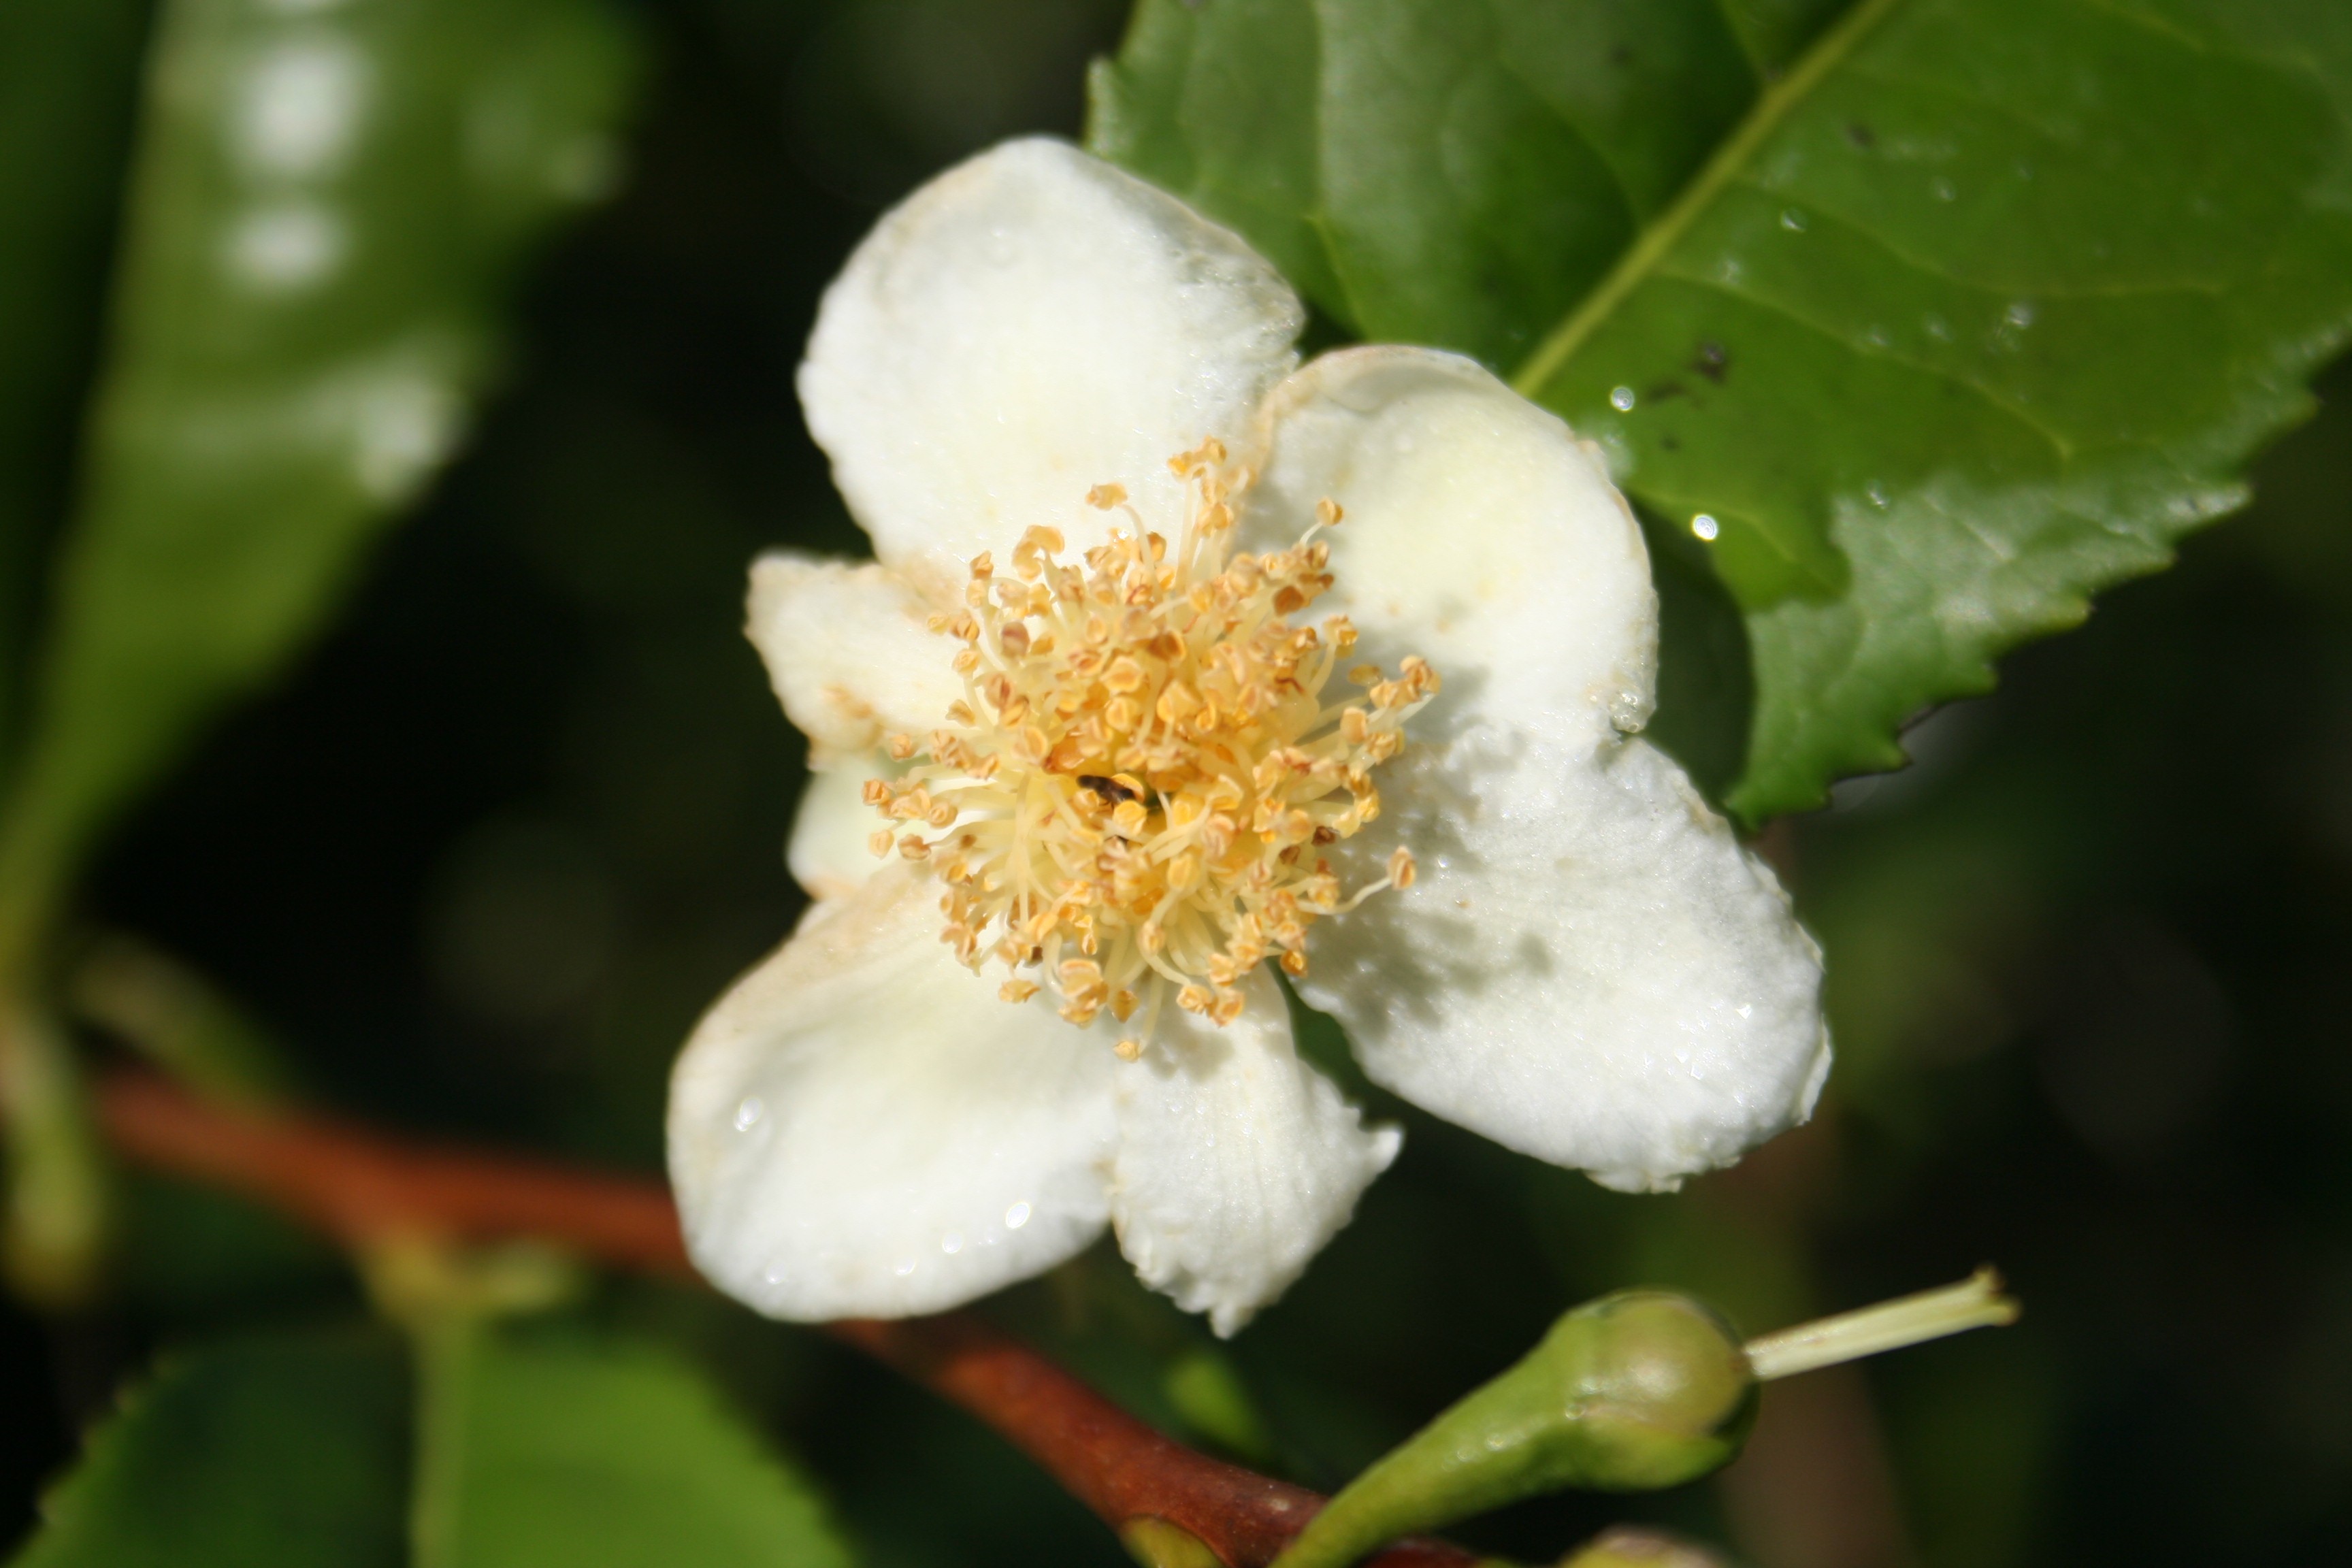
left=670, top=141, right=1830, bottom=1333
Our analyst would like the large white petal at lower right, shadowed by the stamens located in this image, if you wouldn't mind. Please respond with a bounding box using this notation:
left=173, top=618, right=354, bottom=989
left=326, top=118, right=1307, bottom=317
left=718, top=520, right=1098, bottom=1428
left=1301, top=724, right=1830, bottom=1190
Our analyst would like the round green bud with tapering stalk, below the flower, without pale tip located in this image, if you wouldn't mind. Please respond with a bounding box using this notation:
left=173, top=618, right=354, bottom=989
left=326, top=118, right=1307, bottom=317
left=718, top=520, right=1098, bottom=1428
left=1275, top=1290, right=1757, bottom=1568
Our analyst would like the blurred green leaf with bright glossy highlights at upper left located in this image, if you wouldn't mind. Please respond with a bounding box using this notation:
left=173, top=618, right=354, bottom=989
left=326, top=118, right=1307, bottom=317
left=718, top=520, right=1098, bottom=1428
left=0, top=0, right=628, bottom=959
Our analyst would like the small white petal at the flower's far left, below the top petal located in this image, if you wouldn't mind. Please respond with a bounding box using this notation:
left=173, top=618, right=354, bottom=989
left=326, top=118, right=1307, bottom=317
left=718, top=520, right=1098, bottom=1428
left=743, top=550, right=964, bottom=764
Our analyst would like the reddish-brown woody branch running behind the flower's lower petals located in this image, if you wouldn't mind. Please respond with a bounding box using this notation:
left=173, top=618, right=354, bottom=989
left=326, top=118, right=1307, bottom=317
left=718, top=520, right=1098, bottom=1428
left=99, top=1072, right=1480, bottom=1568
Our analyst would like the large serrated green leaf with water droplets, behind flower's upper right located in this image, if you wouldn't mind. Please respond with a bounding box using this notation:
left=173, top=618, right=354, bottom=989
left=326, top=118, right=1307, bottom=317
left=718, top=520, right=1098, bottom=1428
left=1094, top=0, right=2352, bottom=821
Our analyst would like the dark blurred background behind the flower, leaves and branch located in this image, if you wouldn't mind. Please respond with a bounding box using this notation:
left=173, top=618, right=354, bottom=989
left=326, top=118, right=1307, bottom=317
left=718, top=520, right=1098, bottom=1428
left=0, top=0, right=2352, bottom=1568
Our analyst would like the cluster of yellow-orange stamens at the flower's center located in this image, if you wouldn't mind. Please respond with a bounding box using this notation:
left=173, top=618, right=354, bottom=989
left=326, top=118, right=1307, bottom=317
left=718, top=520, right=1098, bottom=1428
left=866, top=440, right=1437, bottom=1060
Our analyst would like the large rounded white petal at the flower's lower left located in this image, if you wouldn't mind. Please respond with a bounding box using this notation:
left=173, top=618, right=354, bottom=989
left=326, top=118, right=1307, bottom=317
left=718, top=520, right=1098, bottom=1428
left=668, top=868, right=1117, bottom=1321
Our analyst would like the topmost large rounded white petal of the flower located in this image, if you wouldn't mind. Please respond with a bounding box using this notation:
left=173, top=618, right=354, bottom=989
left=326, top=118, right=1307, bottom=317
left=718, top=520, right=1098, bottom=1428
left=800, top=139, right=1303, bottom=583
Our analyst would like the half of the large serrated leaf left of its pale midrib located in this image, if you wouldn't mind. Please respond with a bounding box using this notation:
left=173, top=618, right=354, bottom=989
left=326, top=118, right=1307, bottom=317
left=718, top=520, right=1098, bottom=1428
left=1087, top=0, right=1835, bottom=364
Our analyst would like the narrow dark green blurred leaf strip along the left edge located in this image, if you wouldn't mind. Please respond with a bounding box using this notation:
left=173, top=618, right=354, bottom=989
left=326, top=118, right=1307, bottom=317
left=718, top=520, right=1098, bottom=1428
left=0, top=0, right=148, bottom=760
